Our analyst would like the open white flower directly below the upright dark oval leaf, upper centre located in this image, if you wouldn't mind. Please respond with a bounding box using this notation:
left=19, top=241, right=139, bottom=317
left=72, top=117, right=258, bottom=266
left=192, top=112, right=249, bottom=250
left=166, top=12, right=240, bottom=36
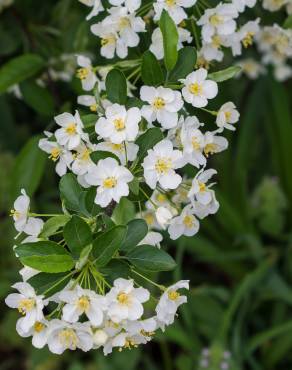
left=95, top=104, right=141, bottom=144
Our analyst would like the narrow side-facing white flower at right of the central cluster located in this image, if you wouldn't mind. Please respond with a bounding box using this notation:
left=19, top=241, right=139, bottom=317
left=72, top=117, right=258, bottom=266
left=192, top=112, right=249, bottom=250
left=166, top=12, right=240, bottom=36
left=180, top=116, right=206, bottom=168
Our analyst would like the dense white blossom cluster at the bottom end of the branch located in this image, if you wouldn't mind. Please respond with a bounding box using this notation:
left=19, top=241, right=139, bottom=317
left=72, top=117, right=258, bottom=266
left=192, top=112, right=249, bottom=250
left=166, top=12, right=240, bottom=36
left=5, top=278, right=189, bottom=355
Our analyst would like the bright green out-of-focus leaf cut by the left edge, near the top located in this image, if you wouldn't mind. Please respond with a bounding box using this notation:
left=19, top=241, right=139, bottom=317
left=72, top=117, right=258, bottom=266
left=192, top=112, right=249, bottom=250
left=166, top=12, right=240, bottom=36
left=0, top=54, right=45, bottom=94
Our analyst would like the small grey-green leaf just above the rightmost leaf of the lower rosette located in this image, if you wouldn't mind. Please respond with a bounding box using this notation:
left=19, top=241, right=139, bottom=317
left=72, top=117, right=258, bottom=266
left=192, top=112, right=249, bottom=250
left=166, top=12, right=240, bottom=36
left=120, top=219, right=148, bottom=252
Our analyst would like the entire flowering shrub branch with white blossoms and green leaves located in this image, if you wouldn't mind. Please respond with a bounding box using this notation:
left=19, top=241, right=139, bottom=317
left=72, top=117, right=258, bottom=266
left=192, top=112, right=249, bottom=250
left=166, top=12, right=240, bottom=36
left=2, top=0, right=292, bottom=363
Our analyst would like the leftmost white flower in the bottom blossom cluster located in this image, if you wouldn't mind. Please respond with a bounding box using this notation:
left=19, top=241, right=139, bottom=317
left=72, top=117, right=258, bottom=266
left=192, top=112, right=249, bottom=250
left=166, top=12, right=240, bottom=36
left=5, top=282, right=44, bottom=333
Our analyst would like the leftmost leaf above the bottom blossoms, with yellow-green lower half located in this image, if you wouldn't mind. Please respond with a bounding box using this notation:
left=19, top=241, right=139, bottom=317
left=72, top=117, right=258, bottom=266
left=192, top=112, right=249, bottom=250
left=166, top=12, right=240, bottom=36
left=15, top=241, right=74, bottom=273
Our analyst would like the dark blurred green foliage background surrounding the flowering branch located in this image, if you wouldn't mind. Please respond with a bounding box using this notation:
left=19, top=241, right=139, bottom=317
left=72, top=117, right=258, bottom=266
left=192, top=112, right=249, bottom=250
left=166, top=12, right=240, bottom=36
left=0, top=0, right=292, bottom=370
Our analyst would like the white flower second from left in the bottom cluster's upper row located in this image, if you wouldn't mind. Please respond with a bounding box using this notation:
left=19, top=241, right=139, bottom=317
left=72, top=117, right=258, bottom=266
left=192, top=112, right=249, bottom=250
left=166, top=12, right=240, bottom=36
left=59, top=285, right=106, bottom=326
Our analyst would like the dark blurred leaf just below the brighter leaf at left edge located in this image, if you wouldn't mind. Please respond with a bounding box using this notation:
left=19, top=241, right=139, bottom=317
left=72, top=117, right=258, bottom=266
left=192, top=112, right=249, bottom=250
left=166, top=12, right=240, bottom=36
left=20, top=80, right=55, bottom=116
